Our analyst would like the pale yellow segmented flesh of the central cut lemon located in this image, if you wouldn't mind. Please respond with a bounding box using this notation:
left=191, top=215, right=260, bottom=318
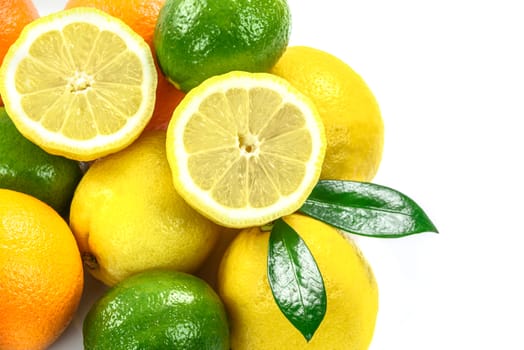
left=184, top=88, right=312, bottom=208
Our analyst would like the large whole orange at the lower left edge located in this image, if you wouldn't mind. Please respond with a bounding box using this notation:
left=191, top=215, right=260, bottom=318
left=0, top=189, right=84, bottom=350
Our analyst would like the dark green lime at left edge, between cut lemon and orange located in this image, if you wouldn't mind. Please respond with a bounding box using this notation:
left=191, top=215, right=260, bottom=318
left=0, top=107, right=82, bottom=218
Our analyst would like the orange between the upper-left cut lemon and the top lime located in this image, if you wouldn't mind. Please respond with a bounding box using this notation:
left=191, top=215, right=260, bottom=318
left=65, top=0, right=184, bottom=130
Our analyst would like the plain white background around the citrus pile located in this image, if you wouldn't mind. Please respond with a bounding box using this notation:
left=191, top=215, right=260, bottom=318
left=29, top=0, right=524, bottom=350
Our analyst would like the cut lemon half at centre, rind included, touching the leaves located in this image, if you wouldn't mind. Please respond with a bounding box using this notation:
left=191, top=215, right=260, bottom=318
left=167, top=72, right=326, bottom=228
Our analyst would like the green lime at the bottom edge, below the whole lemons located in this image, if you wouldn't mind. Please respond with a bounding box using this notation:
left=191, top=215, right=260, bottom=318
left=83, top=270, right=229, bottom=350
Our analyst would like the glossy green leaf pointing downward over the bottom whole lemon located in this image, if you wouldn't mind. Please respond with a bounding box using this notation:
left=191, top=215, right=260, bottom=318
left=267, top=219, right=327, bottom=341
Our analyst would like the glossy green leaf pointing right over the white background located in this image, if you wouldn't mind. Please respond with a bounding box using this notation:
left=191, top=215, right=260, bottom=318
left=299, top=180, right=438, bottom=237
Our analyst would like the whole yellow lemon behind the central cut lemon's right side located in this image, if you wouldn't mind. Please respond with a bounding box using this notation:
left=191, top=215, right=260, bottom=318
left=272, top=46, right=384, bottom=181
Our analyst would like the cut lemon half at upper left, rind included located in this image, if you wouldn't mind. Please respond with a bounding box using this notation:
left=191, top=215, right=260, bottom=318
left=0, top=8, right=157, bottom=161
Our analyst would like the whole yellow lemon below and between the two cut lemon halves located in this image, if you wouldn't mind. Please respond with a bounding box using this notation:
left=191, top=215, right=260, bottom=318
left=70, top=131, right=220, bottom=285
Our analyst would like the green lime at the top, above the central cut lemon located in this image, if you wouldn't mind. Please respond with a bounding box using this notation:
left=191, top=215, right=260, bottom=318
left=154, top=0, right=291, bottom=92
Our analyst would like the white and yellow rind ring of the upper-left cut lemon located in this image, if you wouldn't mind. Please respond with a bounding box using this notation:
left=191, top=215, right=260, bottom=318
left=0, top=7, right=157, bottom=161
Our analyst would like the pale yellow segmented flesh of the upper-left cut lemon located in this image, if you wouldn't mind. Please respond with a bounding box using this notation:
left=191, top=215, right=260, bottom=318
left=15, top=23, right=143, bottom=140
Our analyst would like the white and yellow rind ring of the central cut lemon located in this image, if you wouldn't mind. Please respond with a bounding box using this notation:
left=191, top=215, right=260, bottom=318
left=167, top=72, right=326, bottom=228
